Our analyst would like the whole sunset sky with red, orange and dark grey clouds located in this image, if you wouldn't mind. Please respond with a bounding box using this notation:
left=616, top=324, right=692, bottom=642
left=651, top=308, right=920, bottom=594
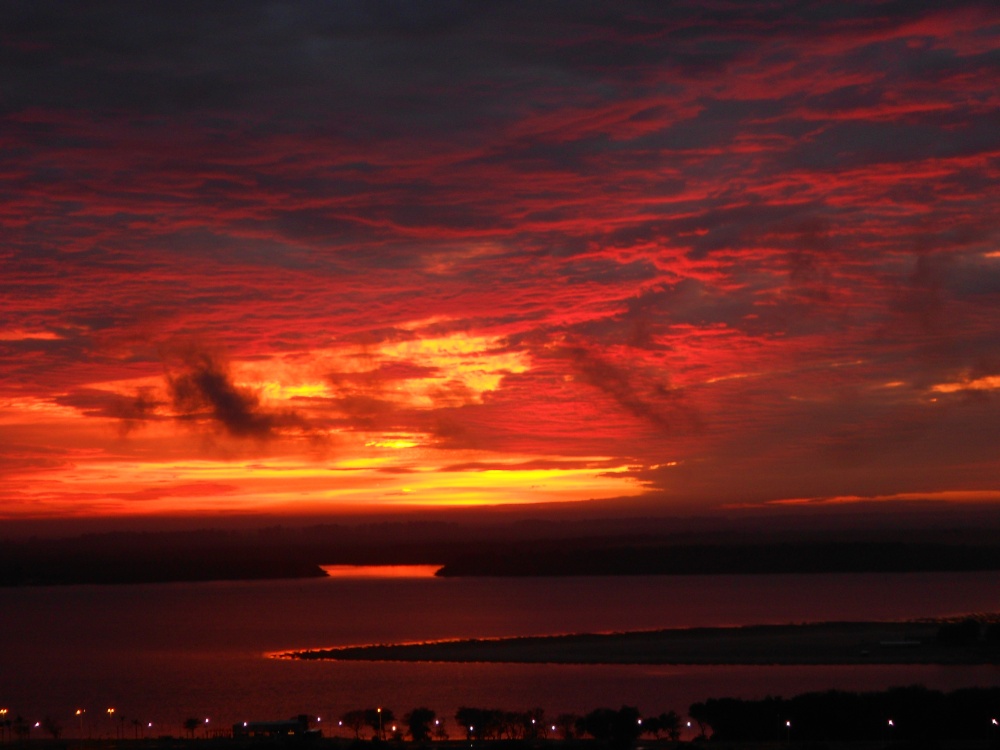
left=0, top=0, right=1000, bottom=520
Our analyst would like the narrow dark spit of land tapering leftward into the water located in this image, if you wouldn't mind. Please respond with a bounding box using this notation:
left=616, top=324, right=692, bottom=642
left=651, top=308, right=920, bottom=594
left=276, top=620, right=1000, bottom=665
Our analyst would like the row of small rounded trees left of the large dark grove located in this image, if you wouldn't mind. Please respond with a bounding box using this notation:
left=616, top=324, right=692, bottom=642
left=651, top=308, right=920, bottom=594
left=339, top=706, right=681, bottom=746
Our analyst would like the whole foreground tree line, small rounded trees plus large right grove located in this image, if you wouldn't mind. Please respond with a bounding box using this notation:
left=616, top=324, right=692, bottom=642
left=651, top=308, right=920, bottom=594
left=332, top=686, right=1000, bottom=747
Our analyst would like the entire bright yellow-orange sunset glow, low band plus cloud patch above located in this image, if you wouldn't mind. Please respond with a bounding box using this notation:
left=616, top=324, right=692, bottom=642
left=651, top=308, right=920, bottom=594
left=0, top=328, right=644, bottom=518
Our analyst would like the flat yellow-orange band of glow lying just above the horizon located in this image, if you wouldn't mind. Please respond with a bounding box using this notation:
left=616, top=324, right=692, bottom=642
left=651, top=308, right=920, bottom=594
left=0, top=450, right=643, bottom=518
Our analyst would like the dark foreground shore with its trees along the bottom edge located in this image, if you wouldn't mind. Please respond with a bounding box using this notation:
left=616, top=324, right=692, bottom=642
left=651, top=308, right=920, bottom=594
left=8, top=685, right=1000, bottom=750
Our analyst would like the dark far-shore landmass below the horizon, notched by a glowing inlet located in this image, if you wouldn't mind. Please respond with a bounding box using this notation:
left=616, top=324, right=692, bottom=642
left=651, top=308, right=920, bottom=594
left=0, top=519, right=1000, bottom=586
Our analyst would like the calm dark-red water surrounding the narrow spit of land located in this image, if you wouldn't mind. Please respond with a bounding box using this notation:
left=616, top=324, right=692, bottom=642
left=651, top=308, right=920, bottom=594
left=0, top=573, right=1000, bottom=736
